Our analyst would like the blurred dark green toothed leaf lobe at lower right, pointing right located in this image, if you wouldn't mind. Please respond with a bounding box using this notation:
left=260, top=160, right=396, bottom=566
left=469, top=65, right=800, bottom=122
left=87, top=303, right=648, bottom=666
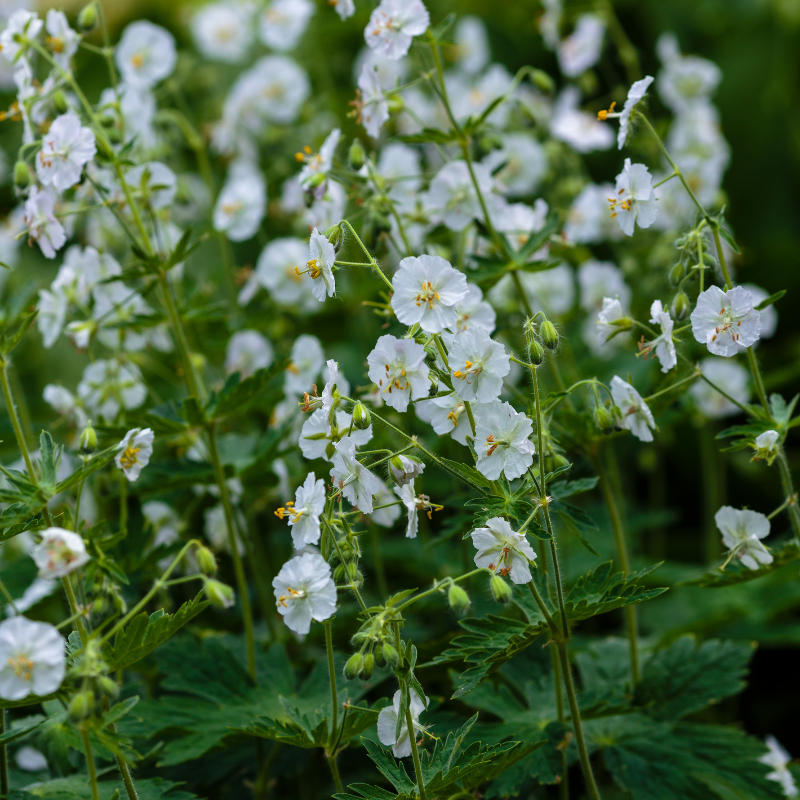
left=636, top=636, right=754, bottom=720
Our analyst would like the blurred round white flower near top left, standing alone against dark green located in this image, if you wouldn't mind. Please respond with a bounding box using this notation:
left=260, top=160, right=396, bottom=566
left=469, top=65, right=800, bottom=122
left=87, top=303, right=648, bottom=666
left=114, top=20, right=178, bottom=88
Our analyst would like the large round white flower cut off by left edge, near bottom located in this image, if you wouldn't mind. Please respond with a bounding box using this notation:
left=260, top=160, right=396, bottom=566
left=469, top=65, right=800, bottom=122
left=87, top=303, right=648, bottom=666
left=0, top=617, right=66, bottom=700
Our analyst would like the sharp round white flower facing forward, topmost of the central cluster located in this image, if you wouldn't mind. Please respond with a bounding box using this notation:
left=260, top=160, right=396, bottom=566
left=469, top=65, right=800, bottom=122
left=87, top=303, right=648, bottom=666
left=392, top=255, right=467, bottom=333
